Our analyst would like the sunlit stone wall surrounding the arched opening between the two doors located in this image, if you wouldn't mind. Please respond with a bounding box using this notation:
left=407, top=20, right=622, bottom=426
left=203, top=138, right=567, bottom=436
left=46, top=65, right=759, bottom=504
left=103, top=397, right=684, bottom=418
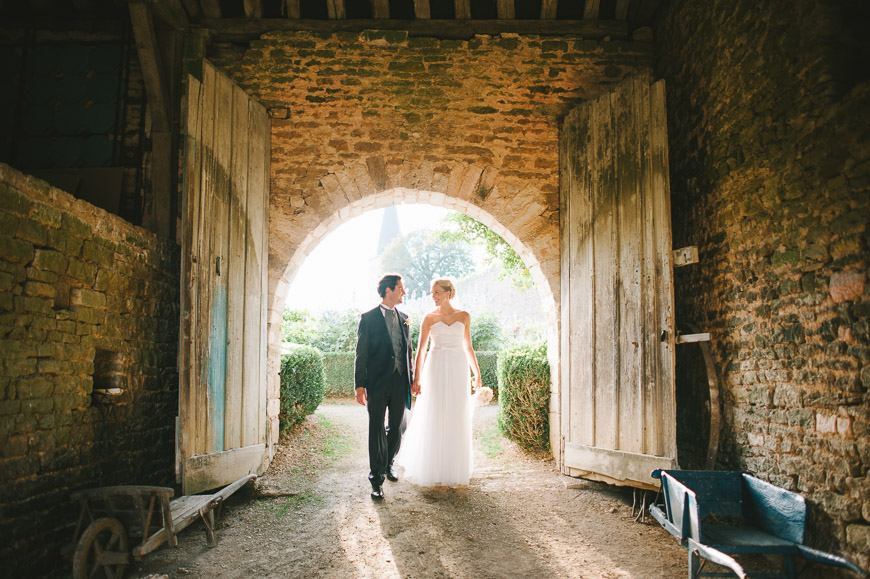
left=208, top=30, right=652, bottom=456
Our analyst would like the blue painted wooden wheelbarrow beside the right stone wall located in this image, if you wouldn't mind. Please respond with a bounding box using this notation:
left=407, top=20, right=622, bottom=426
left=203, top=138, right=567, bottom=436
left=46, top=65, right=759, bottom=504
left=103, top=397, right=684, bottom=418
left=650, top=470, right=870, bottom=579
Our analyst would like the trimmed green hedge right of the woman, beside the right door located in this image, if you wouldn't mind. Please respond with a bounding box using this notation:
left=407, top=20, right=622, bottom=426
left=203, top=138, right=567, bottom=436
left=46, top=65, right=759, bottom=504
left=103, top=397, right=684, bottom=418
left=498, top=344, right=550, bottom=451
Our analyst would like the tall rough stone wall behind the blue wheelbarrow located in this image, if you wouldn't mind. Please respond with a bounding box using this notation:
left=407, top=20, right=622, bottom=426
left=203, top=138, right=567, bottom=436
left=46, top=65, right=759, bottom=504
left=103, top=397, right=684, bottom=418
left=654, top=0, right=870, bottom=576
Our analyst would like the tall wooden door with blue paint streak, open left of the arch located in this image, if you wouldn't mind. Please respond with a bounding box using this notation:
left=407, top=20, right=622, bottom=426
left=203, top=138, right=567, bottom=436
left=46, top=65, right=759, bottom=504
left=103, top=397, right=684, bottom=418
left=178, top=61, right=270, bottom=494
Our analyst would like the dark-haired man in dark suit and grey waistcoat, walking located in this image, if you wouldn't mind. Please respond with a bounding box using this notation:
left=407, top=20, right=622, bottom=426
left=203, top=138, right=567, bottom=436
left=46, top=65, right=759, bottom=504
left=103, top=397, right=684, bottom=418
left=353, top=274, right=414, bottom=500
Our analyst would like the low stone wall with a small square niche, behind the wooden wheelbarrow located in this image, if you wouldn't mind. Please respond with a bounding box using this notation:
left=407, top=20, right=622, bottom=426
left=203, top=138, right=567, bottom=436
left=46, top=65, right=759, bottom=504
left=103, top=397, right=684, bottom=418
left=0, top=164, right=179, bottom=577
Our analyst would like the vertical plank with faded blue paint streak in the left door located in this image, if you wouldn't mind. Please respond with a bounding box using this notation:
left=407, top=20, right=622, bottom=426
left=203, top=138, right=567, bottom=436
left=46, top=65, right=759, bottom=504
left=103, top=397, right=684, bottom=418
left=207, top=63, right=233, bottom=452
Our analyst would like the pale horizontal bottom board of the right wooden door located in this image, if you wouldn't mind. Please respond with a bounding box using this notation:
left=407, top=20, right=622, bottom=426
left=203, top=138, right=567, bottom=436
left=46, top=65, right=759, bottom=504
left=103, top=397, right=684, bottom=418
left=565, top=443, right=676, bottom=489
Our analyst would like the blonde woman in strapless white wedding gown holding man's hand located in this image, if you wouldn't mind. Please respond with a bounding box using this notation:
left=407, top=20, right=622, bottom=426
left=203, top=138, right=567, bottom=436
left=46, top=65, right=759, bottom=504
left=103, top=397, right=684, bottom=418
left=396, top=279, right=481, bottom=487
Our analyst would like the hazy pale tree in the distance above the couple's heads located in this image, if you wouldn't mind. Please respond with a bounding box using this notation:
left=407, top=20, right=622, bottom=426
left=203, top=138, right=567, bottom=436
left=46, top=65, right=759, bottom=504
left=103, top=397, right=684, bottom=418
left=381, top=230, right=475, bottom=297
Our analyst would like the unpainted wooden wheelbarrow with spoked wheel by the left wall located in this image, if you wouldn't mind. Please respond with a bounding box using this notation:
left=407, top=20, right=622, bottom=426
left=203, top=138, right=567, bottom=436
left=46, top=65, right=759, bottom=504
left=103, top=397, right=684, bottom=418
left=68, top=474, right=257, bottom=579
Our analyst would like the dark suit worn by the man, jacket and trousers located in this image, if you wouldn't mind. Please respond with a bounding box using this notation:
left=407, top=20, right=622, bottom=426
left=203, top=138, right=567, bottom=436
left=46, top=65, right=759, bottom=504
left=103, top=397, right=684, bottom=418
left=353, top=306, right=414, bottom=487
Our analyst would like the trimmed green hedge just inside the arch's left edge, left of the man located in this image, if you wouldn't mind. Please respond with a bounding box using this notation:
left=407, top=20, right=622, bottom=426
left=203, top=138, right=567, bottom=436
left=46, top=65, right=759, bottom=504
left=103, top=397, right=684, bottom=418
left=278, top=346, right=323, bottom=434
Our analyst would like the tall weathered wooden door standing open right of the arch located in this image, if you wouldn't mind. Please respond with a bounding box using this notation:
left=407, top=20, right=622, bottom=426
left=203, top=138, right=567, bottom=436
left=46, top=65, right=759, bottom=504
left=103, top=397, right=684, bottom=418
left=560, top=76, right=676, bottom=488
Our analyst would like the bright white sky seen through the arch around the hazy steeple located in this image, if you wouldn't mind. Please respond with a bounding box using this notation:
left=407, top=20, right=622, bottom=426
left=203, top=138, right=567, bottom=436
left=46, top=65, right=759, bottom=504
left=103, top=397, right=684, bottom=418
left=285, top=204, right=451, bottom=313
